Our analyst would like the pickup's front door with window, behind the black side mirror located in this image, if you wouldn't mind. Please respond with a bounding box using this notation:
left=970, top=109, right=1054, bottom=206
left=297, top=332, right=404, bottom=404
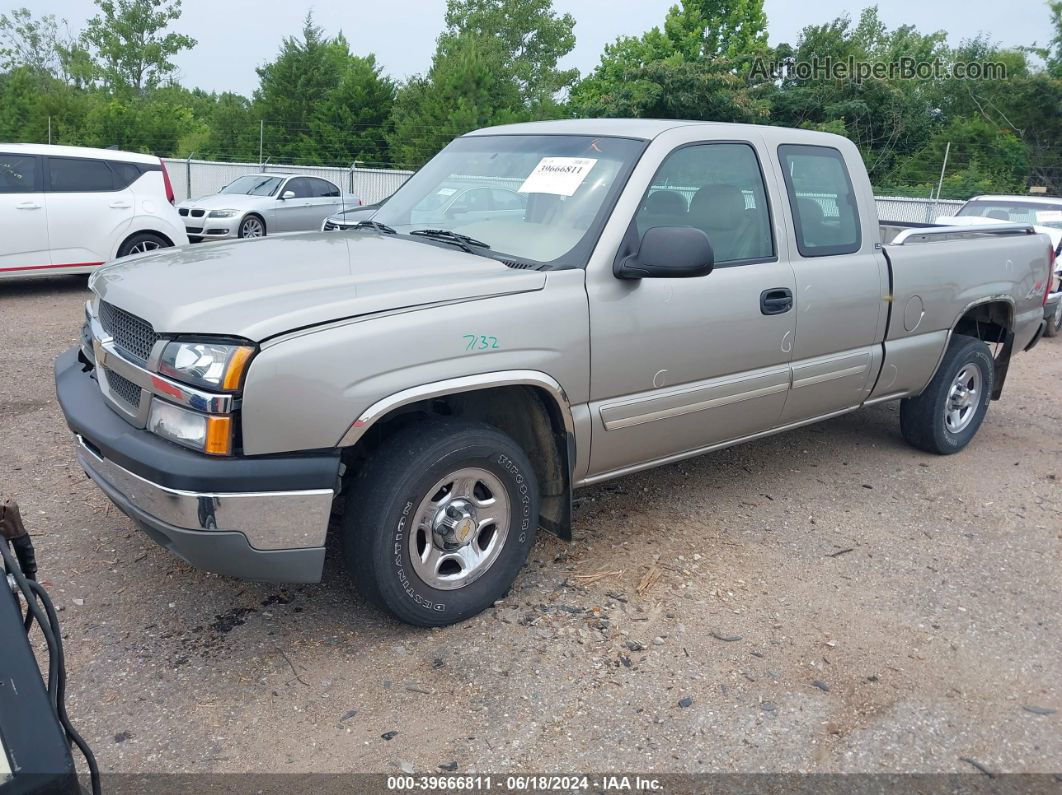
left=587, top=141, right=795, bottom=476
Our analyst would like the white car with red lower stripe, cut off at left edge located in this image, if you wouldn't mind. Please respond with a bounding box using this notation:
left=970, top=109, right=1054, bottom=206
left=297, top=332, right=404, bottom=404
left=0, top=143, right=188, bottom=279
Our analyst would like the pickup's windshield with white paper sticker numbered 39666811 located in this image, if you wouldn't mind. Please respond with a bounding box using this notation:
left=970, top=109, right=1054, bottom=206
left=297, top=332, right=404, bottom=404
left=373, top=135, right=646, bottom=266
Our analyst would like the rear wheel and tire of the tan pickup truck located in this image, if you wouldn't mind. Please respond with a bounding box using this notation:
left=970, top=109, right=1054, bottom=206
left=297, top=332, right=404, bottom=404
left=900, top=336, right=995, bottom=455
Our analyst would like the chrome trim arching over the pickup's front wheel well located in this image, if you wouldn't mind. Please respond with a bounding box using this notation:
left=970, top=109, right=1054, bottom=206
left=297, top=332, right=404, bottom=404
left=336, top=370, right=576, bottom=450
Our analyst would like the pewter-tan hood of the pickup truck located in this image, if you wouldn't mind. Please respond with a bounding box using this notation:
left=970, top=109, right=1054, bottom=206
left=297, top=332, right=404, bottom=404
left=90, top=231, right=546, bottom=342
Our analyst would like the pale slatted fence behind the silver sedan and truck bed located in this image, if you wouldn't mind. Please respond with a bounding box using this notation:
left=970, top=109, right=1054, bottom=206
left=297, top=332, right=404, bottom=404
left=164, top=158, right=964, bottom=224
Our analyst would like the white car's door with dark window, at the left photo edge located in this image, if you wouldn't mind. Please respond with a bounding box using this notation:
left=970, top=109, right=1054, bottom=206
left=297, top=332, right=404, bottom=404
left=0, top=152, right=52, bottom=277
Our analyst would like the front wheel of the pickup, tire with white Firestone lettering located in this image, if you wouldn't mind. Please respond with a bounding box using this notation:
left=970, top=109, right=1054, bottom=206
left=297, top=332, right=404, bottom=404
left=342, top=419, right=538, bottom=626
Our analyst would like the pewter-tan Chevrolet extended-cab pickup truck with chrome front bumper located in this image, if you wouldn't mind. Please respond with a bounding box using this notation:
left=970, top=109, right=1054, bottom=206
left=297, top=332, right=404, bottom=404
left=55, top=120, right=1054, bottom=626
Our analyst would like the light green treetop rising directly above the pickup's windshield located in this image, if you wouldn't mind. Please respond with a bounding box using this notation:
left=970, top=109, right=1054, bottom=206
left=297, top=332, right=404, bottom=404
left=439, top=0, right=579, bottom=107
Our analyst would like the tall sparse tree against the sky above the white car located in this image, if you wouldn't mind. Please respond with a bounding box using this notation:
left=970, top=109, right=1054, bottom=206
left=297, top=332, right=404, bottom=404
left=83, top=0, right=195, bottom=94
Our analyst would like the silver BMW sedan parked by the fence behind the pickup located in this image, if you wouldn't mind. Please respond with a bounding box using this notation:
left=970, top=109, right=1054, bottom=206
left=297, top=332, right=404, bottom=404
left=177, top=173, right=361, bottom=243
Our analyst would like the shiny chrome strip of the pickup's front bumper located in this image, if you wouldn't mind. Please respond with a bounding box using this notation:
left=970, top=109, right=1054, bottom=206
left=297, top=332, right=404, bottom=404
left=78, top=435, right=336, bottom=550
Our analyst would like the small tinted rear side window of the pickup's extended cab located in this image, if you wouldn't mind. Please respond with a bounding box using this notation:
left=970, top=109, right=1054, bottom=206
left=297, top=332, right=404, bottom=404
left=778, top=143, right=862, bottom=257
